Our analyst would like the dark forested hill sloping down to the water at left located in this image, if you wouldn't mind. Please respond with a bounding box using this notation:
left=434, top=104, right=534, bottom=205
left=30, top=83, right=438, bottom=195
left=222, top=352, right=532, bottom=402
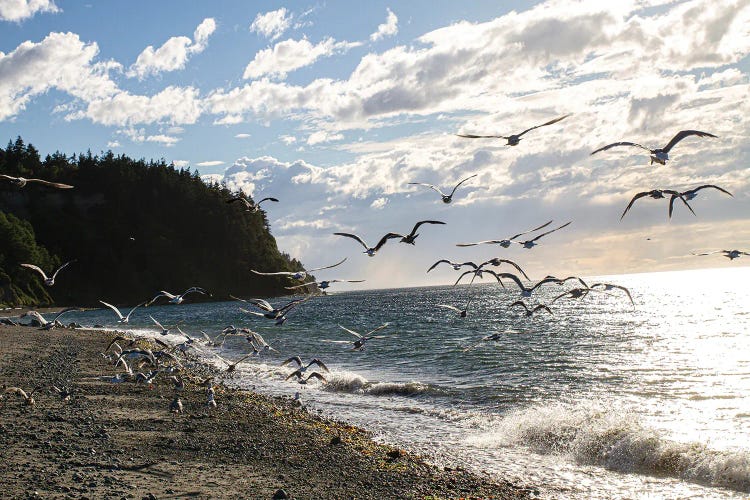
left=0, top=138, right=302, bottom=306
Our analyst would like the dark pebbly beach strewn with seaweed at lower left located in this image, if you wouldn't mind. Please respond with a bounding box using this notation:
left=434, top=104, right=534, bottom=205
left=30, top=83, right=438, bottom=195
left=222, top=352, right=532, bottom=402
left=0, top=326, right=533, bottom=498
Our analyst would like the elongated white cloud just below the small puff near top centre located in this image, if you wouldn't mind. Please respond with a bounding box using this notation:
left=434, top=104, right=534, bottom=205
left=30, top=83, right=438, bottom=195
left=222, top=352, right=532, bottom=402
left=242, top=38, right=359, bottom=79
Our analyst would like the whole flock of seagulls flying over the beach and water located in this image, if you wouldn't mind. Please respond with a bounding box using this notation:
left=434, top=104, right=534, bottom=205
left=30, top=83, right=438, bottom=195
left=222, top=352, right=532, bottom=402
left=0, top=115, right=750, bottom=412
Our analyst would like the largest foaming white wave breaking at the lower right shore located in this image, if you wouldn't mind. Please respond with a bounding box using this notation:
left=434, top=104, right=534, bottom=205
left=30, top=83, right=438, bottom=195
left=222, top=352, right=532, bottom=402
left=472, top=404, right=750, bottom=493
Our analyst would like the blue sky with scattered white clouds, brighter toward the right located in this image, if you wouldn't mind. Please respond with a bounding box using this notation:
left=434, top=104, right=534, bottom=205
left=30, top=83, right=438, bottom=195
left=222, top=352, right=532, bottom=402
left=0, top=0, right=750, bottom=290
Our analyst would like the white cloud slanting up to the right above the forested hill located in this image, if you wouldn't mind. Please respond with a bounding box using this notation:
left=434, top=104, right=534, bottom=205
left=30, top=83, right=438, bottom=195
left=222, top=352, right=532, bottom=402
left=127, top=17, right=216, bottom=78
